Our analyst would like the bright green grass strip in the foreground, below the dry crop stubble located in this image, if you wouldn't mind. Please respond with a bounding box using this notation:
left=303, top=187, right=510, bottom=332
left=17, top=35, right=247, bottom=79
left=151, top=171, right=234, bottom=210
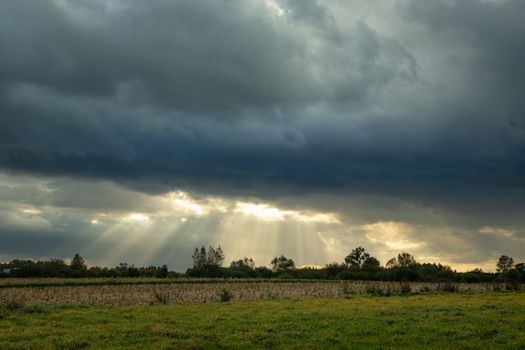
left=0, top=293, right=525, bottom=349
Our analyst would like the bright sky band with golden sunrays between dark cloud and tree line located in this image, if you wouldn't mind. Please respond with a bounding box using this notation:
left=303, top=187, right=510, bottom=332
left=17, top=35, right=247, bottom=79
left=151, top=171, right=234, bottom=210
left=0, top=170, right=522, bottom=270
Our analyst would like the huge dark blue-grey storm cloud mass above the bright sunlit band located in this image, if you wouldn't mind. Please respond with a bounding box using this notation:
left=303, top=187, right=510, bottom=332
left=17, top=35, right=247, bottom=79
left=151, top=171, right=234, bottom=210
left=0, top=0, right=525, bottom=227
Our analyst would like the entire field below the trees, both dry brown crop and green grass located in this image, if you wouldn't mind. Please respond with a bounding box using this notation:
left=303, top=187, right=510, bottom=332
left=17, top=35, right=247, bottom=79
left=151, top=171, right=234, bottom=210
left=0, top=279, right=525, bottom=349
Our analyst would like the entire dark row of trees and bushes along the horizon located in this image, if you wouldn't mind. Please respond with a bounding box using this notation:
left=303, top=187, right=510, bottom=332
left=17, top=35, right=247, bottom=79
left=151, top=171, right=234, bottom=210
left=0, top=246, right=525, bottom=283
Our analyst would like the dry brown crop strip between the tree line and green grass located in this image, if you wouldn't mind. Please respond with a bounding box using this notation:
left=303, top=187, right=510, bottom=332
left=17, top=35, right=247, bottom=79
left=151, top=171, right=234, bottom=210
left=0, top=281, right=523, bottom=305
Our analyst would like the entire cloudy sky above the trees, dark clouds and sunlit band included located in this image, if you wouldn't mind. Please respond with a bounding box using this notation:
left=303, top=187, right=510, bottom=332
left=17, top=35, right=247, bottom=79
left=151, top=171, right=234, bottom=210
left=0, top=0, right=525, bottom=271
